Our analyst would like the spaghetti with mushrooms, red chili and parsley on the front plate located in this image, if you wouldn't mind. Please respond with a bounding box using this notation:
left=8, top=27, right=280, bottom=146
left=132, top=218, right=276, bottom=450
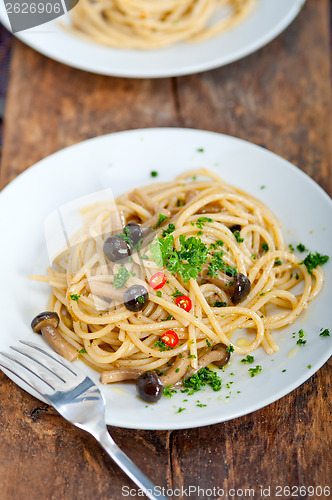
left=34, top=169, right=324, bottom=398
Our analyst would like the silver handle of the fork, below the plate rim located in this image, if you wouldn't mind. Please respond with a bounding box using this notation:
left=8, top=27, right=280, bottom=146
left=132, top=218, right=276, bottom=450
left=98, top=428, right=169, bottom=500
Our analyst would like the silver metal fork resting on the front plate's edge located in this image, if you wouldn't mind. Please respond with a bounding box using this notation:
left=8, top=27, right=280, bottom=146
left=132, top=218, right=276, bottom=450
left=0, top=340, right=167, bottom=500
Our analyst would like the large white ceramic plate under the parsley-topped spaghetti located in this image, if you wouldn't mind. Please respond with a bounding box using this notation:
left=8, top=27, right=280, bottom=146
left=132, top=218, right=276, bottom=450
left=0, top=128, right=332, bottom=429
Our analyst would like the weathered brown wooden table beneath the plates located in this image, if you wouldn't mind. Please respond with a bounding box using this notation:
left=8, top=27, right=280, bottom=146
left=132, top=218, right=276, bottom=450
left=0, top=0, right=332, bottom=500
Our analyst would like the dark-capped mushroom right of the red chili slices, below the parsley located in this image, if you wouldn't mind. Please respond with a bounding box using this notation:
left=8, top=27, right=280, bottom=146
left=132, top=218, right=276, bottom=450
left=200, top=265, right=251, bottom=304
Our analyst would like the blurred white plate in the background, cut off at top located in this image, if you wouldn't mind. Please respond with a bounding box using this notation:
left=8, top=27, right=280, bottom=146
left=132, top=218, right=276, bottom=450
left=0, top=0, right=305, bottom=78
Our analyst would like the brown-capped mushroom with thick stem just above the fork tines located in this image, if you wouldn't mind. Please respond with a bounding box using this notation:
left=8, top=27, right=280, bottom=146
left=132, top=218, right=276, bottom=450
left=31, top=311, right=78, bottom=361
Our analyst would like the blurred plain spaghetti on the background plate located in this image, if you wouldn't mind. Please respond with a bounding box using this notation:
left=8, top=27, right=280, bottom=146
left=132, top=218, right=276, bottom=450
left=65, top=0, right=256, bottom=50
